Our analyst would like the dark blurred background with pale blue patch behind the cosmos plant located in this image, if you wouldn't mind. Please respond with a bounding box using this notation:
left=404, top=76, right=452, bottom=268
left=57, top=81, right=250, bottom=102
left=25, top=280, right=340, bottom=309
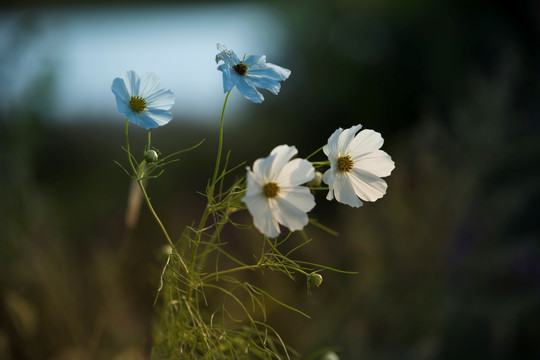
left=0, top=0, right=540, bottom=360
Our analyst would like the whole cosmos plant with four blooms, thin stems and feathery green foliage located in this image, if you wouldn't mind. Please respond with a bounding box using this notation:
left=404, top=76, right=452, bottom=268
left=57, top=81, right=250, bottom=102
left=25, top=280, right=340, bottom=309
left=112, top=44, right=394, bottom=359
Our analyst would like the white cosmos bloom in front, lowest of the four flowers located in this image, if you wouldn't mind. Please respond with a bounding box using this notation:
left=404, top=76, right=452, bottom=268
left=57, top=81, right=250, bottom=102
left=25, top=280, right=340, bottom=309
left=242, top=145, right=315, bottom=238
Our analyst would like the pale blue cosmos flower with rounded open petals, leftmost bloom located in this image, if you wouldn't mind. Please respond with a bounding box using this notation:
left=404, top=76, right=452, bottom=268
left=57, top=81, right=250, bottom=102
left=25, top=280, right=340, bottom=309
left=111, top=70, right=174, bottom=130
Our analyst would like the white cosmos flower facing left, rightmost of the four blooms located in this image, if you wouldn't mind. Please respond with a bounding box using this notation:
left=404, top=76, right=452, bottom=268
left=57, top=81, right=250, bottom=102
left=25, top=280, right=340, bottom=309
left=323, top=125, right=394, bottom=207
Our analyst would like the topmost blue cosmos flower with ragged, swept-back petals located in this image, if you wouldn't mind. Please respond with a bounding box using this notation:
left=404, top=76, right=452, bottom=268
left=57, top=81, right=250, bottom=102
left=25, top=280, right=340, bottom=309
left=216, top=44, right=291, bottom=103
